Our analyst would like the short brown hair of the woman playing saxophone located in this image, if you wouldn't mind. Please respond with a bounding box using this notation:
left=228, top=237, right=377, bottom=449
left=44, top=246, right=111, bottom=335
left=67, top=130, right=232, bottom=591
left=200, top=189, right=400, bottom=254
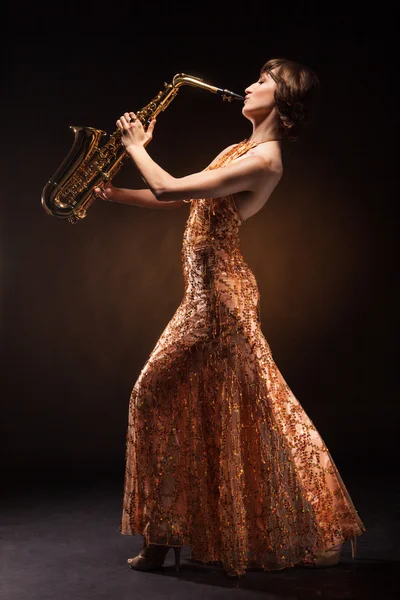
left=261, top=58, right=320, bottom=141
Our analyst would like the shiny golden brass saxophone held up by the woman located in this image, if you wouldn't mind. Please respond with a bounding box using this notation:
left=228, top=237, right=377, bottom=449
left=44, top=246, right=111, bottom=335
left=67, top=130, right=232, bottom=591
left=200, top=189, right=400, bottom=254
left=41, top=73, right=244, bottom=224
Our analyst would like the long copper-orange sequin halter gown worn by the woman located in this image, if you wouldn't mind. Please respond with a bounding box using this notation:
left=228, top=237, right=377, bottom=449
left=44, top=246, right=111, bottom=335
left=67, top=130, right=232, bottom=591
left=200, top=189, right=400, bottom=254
left=120, top=142, right=365, bottom=575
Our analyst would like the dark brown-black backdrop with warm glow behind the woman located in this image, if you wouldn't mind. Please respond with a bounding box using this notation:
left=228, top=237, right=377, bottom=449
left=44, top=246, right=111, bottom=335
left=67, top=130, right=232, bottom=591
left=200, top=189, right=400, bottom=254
left=1, top=1, right=399, bottom=485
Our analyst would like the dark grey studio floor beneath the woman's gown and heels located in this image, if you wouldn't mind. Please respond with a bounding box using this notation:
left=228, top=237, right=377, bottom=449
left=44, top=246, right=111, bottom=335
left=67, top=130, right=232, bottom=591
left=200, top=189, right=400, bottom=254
left=0, top=469, right=400, bottom=600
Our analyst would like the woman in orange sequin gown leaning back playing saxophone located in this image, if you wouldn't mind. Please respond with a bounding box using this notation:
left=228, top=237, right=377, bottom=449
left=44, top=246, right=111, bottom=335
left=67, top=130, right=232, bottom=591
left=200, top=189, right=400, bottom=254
left=97, top=59, right=365, bottom=577
